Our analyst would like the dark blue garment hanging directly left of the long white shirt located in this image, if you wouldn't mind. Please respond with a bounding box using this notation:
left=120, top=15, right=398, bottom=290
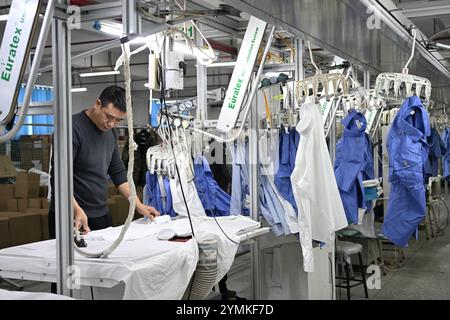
left=275, top=129, right=300, bottom=212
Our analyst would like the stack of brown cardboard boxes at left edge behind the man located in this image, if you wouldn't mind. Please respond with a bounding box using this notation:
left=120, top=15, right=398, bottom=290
left=0, top=172, right=49, bottom=248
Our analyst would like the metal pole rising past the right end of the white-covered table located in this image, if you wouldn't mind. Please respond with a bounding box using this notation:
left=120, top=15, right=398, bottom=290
left=250, top=80, right=261, bottom=300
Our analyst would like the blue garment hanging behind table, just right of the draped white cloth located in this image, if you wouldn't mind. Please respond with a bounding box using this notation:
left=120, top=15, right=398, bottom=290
left=194, top=156, right=231, bottom=216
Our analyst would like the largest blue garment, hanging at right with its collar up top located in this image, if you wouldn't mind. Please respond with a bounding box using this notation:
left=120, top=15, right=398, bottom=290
left=382, top=96, right=431, bottom=247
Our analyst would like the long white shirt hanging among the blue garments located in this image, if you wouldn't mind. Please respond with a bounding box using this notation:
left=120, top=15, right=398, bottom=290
left=291, top=104, right=348, bottom=272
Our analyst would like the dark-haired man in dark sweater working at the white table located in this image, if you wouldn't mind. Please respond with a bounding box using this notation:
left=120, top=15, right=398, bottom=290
left=48, top=86, right=160, bottom=239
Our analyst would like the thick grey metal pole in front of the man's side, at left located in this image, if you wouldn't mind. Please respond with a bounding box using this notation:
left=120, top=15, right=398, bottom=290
left=52, top=0, right=74, bottom=296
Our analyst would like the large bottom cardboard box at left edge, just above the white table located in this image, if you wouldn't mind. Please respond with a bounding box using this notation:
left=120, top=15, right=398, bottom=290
left=2, top=212, right=42, bottom=246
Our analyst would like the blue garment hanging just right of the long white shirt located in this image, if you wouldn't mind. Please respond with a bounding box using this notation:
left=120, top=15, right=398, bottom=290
left=334, top=110, right=375, bottom=224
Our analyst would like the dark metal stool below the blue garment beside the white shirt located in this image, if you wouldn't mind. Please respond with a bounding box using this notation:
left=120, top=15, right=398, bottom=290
left=336, top=241, right=369, bottom=300
